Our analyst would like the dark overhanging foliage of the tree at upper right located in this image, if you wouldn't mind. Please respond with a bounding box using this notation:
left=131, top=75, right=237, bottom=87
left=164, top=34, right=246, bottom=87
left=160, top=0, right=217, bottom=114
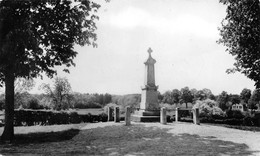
left=218, top=0, right=260, bottom=88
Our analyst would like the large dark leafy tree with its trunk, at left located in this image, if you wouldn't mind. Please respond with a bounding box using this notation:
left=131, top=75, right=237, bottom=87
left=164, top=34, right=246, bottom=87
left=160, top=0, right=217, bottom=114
left=0, top=0, right=100, bottom=141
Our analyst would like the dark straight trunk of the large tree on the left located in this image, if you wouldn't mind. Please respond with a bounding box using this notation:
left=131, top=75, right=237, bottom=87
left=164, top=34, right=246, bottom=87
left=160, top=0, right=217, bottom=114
left=1, top=71, right=14, bottom=142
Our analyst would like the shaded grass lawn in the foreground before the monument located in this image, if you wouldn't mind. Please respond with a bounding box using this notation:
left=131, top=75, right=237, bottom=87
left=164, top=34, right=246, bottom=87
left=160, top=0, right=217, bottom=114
left=0, top=124, right=252, bottom=155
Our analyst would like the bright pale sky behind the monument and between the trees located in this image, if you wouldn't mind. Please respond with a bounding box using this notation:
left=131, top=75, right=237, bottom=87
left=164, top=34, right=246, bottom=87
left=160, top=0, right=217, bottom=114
left=4, top=0, right=254, bottom=95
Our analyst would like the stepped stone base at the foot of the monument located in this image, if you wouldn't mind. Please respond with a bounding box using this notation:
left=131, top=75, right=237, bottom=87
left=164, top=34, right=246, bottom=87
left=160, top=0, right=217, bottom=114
left=131, top=110, right=160, bottom=122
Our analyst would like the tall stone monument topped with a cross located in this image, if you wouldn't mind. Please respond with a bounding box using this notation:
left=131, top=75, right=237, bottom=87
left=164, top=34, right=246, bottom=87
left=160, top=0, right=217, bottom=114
left=132, top=48, right=160, bottom=122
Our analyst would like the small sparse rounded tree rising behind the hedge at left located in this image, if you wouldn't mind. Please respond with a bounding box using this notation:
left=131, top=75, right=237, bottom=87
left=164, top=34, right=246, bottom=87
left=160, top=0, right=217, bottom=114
left=42, top=77, right=72, bottom=110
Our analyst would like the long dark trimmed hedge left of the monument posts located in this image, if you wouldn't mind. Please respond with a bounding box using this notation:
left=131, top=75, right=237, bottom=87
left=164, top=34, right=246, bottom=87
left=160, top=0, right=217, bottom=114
left=14, top=110, right=108, bottom=126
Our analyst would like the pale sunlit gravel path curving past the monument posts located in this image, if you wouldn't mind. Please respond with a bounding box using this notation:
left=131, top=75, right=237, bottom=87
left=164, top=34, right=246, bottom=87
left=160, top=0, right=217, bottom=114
left=82, top=122, right=260, bottom=156
